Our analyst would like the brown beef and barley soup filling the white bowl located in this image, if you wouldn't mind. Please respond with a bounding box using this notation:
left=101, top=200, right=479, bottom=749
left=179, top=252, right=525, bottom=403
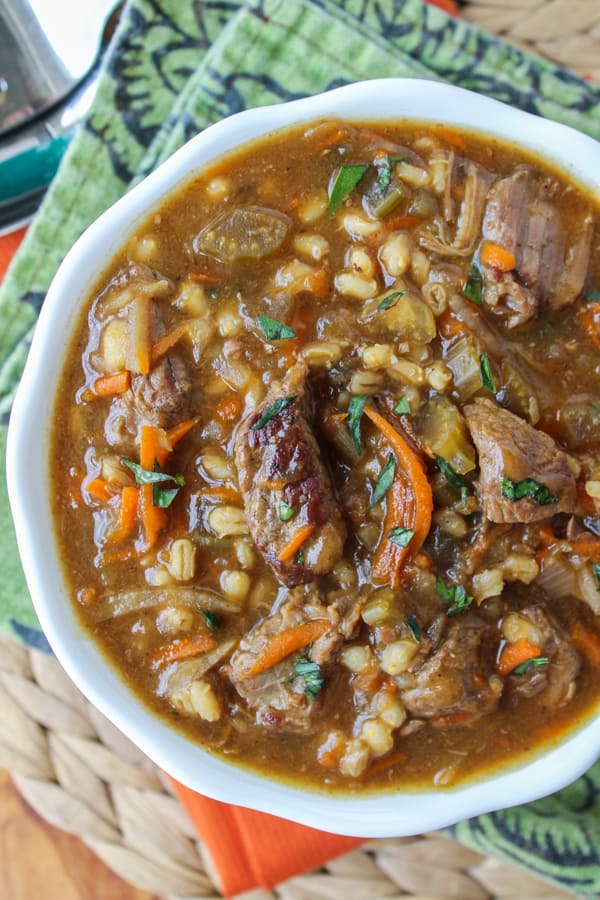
left=51, top=121, right=600, bottom=790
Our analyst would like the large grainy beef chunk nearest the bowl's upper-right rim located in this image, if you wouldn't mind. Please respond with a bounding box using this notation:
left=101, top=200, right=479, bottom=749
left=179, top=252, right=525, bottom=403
left=482, top=166, right=593, bottom=327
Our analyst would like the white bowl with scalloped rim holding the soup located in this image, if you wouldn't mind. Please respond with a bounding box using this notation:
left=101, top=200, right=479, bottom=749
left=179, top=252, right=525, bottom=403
left=8, top=79, right=600, bottom=837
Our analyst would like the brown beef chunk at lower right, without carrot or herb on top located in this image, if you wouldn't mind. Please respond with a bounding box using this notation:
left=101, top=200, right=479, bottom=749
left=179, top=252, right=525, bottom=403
left=400, top=620, right=502, bottom=720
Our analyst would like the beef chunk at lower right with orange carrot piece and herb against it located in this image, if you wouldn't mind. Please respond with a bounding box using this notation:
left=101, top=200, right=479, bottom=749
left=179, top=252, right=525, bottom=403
left=507, top=603, right=581, bottom=707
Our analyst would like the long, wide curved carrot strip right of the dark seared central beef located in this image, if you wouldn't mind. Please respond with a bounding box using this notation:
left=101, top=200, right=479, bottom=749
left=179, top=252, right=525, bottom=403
left=365, top=404, right=433, bottom=588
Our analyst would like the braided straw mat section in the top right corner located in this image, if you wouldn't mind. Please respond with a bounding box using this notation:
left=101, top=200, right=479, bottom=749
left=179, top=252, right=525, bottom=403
left=459, top=0, right=600, bottom=81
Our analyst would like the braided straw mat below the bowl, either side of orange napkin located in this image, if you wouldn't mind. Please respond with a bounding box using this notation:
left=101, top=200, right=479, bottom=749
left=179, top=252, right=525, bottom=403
left=0, top=636, right=574, bottom=900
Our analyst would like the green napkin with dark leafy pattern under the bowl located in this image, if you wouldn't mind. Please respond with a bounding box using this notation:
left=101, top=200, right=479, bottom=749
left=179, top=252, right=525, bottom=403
left=0, top=0, right=600, bottom=896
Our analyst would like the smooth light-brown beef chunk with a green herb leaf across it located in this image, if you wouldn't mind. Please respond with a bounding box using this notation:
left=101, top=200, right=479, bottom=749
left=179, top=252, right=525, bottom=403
left=464, top=398, right=576, bottom=523
